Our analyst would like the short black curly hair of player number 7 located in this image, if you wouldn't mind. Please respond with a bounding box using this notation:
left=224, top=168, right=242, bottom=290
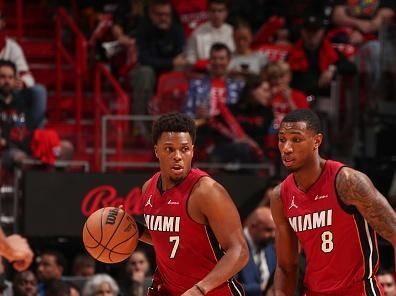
left=152, top=112, right=197, bottom=144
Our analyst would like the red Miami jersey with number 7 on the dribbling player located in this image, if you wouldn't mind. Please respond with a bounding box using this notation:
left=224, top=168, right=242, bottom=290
left=142, top=169, right=244, bottom=296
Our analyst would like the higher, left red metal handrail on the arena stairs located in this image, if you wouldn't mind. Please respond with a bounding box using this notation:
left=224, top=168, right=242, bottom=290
left=55, top=8, right=87, bottom=150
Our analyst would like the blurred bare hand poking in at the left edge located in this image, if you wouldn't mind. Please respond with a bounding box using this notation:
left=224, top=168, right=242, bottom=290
left=4, top=234, right=34, bottom=271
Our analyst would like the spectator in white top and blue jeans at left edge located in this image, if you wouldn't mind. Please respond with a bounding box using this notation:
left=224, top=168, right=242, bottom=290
left=0, top=12, right=47, bottom=127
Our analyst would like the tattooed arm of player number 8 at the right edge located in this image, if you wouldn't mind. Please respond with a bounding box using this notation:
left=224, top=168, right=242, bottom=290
left=336, top=167, right=396, bottom=247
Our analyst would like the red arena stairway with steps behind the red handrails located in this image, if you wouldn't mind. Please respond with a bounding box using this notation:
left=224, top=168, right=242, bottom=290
left=0, top=0, right=158, bottom=170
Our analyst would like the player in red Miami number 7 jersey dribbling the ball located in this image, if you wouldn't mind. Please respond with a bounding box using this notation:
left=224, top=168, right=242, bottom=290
left=136, top=113, right=249, bottom=296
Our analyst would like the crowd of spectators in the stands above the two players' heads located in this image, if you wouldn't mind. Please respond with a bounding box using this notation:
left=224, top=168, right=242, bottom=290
left=75, top=0, right=395, bottom=171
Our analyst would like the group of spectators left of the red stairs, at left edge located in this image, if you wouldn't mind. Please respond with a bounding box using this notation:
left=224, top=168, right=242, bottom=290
left=0, top=12, right=74, bottom=179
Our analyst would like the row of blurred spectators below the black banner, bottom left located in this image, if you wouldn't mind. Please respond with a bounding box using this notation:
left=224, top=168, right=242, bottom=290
left=0, top=249, right=152, bottom=296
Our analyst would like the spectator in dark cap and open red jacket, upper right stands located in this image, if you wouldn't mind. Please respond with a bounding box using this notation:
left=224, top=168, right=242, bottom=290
left=288, top=15, right=355, bottom=96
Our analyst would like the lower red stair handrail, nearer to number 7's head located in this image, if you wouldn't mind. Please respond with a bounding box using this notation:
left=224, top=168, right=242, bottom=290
left=94, top=63, right=130, bottom=170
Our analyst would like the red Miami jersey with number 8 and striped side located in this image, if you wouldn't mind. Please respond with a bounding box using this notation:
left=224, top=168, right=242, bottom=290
left=281, top=160, right=382, bottom=296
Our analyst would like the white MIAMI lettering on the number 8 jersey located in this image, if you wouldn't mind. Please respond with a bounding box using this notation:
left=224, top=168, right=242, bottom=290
left=289, top=210, right=333, bottom=232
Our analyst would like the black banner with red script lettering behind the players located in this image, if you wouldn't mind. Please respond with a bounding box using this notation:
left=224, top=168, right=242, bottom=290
left=23, top=171, right=266, bottom=237
